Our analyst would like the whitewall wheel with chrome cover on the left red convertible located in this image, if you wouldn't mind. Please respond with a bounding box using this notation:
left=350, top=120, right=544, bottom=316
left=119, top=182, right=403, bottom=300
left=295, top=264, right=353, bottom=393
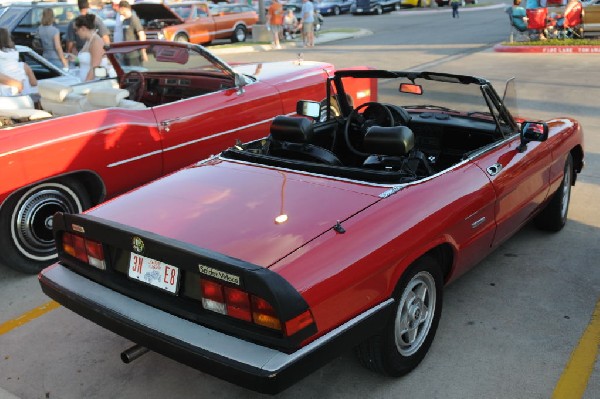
left=0, top=179, right=91, bottom=274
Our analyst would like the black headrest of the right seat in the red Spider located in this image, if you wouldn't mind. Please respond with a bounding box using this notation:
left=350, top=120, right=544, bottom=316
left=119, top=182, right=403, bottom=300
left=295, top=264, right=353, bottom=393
left=363, top=126, right=415, bottom=156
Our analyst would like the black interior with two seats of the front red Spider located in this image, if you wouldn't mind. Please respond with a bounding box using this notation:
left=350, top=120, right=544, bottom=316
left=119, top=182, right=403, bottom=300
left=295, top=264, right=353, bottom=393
left=223, top=102, right=502, bottom=183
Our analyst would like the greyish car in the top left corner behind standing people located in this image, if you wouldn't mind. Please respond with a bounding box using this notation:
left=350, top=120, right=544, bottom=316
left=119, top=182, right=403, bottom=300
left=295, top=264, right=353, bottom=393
left=0, top=2, right=79, bottom=51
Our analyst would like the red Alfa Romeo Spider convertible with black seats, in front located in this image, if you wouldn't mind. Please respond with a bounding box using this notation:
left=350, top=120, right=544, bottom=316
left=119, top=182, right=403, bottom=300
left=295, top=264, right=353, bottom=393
left=39, top=70, right=584, bottom=393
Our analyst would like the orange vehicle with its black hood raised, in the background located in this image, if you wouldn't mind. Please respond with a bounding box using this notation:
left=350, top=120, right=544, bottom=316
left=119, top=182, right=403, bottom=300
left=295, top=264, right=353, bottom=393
left=132, top=1, right=258, bottom=44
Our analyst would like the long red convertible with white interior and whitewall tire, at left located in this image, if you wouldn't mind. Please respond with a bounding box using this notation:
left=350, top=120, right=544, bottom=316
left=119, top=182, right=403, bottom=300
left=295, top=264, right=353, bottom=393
left=0, top=41, right=370, bottom=273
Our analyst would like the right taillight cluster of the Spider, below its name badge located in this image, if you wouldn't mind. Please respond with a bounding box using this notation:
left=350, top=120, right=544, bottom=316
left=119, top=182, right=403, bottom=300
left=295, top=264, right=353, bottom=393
left=200, top=279, right=296, bottom=332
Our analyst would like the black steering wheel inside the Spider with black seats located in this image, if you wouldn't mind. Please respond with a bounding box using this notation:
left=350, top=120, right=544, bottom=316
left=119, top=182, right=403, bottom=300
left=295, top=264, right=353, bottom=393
left=344, top=101, right=394, bottom=157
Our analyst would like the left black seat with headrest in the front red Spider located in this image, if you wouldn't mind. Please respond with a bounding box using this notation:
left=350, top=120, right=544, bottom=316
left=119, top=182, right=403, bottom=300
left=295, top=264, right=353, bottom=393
left=269, top=116, right=342, bottom=166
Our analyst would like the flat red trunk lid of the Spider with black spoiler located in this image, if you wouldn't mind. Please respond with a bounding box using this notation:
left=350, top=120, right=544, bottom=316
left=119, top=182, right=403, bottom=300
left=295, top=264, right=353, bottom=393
left=89, top=160, right=385, bottom=267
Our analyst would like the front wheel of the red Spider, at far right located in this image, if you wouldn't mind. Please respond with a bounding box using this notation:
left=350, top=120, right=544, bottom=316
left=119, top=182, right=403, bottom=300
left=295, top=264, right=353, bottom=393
left=535, top=154, right=573, bottom=231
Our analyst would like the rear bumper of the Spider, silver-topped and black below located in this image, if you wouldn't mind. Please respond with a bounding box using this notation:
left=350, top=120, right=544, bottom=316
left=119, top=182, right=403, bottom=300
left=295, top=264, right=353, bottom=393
left=39, top=264, right=393, bottom=394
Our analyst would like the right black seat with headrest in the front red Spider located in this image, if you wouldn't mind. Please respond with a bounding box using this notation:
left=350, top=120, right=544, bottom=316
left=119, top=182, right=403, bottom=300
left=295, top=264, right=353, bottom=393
left=363, top=126, right=435, bottom=176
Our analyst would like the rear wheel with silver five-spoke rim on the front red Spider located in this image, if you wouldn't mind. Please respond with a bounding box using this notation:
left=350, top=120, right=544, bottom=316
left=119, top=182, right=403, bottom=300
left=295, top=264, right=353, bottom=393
left=355, top=255, right=443, bottom=377
